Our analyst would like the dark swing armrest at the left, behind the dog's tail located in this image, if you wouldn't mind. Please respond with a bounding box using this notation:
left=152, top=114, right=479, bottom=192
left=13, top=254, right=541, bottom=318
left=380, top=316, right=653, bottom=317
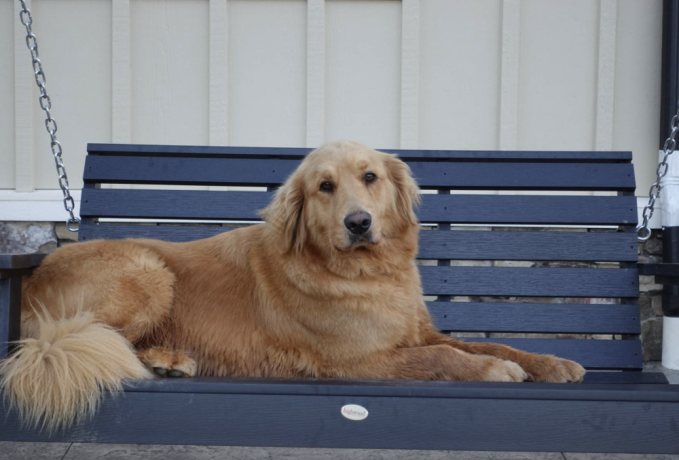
left=0, top=254, right=47, bottom=360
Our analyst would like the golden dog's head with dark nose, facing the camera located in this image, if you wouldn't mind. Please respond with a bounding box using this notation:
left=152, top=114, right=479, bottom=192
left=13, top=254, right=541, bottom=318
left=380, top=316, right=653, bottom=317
left=262, top=142, right=419, bottom=264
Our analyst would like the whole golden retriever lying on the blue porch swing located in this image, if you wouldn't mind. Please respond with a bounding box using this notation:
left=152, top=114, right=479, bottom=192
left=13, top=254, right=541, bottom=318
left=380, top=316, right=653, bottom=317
left=0, top=142, right=585, bottom=431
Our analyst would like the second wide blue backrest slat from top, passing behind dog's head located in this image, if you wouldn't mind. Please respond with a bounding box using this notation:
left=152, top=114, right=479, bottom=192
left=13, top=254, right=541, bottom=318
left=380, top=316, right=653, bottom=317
left=80, top=189, right=637, bottom=225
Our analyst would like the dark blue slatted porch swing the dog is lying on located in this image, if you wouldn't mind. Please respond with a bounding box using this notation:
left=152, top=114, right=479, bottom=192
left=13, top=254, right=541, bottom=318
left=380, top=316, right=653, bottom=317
left=0, top=144, right=679, bottom=453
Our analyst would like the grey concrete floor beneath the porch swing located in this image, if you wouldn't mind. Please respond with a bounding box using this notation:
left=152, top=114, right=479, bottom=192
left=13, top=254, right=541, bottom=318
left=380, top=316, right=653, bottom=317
left=0, top=363, right=679, bottom=460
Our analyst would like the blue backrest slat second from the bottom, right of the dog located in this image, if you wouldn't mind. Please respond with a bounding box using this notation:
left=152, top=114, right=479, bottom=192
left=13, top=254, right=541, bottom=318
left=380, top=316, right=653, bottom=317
left=427, top=302, right=641, bottom=334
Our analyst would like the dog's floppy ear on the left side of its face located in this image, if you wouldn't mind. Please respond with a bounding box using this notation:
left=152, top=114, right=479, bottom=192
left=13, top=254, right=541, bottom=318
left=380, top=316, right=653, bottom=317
left=260, top=171, right=306, bottom=252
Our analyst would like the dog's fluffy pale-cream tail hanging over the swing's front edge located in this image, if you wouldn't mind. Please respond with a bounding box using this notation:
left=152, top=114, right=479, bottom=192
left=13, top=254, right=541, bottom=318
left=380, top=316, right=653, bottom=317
left=0, top=311, right=151, bottom=433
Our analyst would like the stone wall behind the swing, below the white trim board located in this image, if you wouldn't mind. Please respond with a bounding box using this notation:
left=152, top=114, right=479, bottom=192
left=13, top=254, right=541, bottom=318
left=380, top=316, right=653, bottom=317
left=0, top=222, right=662, bottom=361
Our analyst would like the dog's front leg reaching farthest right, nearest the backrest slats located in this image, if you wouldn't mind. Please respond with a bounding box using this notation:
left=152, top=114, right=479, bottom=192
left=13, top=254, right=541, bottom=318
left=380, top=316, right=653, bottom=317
left=425, top=332, right=585, bottom=383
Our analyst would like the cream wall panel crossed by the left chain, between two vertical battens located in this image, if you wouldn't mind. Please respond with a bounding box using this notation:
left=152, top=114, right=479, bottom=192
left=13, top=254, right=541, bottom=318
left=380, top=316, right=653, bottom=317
left=32, top=0, right=111, bottom=189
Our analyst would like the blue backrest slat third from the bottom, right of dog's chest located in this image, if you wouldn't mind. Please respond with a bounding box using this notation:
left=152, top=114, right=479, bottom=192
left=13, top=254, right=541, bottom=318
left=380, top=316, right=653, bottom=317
left=419, top=266, right=639, bottom=297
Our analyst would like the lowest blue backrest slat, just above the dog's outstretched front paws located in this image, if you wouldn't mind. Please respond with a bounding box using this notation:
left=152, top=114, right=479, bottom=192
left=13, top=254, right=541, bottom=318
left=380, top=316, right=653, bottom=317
left=464, top=338, right=644, bottom=369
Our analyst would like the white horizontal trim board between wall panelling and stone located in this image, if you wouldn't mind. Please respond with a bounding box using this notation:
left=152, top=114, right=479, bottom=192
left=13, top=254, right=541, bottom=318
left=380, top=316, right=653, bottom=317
left=0, top=190, right=662, bottom=229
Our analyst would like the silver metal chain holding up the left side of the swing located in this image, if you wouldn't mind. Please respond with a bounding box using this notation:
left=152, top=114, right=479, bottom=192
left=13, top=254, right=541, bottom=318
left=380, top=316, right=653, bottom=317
left=19, top=0, right=80, bottom=232
